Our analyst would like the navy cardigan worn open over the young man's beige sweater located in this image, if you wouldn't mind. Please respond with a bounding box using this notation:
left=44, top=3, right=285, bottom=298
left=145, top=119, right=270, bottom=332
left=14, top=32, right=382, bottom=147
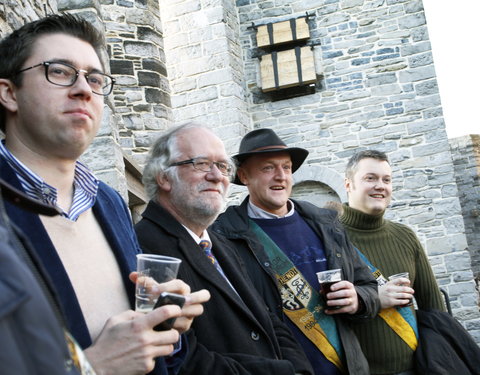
left=0, top=157, right=180, bottom=374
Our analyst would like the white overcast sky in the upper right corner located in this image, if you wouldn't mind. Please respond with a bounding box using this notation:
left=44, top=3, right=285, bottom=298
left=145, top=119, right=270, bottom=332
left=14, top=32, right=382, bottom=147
left=423, top=0, right=480, bottom=138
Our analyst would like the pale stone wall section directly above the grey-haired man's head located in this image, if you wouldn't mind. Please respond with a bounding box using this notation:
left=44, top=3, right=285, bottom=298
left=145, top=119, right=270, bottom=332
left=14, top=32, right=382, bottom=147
left=160, top=0, right=251, bottom=152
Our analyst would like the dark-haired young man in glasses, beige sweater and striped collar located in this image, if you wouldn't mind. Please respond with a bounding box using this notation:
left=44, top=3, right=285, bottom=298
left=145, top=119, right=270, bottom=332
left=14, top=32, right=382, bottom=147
left=0, top=15, right=208, bottom=375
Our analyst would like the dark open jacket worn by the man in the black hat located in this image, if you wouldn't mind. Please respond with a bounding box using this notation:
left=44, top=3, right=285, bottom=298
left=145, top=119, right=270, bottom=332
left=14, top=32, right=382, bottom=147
left=212, top=197, right=380, bottom=375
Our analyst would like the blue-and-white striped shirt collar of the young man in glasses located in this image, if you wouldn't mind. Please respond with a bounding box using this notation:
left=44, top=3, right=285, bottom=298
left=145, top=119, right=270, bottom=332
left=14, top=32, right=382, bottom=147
left=0, top=140, right=99, bottom=221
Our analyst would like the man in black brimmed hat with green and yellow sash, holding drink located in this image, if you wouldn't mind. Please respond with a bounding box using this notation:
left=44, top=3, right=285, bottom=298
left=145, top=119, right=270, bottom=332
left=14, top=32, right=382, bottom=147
left=213, top=129, right=379, bottom=375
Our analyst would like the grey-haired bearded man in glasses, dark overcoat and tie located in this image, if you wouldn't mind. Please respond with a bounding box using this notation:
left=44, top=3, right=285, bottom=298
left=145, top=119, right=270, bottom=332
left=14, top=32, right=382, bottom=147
left=135, top=123, right=312, bottom=375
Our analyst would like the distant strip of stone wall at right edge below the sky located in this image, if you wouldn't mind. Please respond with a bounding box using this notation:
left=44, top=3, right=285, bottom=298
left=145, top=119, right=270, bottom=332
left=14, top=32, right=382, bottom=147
left=450, top=134, right=480, bottom=285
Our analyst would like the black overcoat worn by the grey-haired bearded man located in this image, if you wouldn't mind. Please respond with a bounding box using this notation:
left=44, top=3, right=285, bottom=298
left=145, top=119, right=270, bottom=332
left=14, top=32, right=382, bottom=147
left=135, top=201, right=311, bottom=375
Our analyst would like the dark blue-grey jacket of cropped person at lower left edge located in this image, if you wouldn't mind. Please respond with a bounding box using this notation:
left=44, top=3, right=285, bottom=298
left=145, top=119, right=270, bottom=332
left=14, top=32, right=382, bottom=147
left=0, top=184, right=80, bottom=375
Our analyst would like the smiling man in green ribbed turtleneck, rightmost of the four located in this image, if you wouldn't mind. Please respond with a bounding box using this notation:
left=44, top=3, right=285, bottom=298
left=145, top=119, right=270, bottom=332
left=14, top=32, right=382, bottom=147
left=340, top=150, right=445, bottom=375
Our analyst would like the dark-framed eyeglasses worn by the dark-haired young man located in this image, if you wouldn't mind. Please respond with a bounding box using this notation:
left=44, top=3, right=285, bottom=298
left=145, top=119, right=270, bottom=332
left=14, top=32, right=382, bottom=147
left=17, top=61, right=115, bottom=96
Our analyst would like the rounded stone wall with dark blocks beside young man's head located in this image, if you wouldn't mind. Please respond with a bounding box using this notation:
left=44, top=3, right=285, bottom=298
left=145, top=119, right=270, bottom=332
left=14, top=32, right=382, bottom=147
left=102, top=0, right=172, bottom=164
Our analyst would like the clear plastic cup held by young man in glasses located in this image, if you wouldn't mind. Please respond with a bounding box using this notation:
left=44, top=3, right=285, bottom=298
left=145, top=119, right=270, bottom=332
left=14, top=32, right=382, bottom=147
left=135, top=254, right=182, bottom=313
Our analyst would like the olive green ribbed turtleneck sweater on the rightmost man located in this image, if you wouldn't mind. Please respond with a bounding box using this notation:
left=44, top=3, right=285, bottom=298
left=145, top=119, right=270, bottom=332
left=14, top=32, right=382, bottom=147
left=340, top=204, right=445, bottom=375
